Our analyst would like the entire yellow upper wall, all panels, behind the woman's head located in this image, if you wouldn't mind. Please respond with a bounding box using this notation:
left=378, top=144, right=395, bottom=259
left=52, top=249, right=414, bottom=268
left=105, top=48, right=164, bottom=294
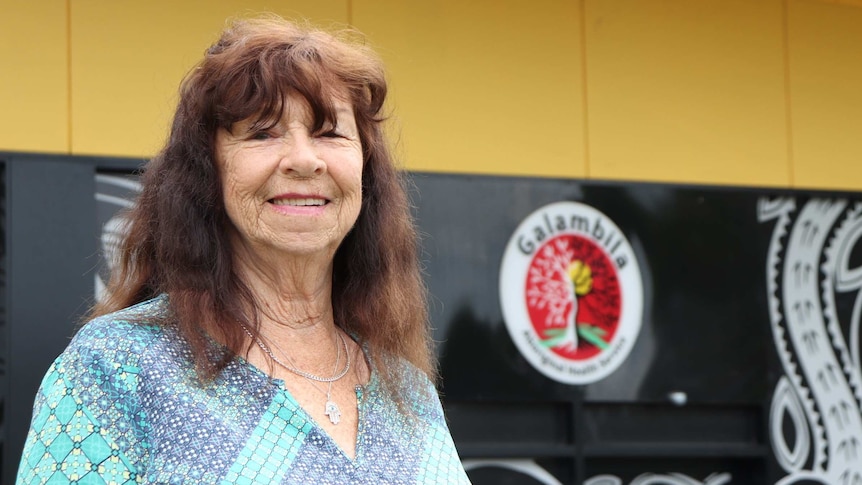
left=8, top=0, right=862, bottom=189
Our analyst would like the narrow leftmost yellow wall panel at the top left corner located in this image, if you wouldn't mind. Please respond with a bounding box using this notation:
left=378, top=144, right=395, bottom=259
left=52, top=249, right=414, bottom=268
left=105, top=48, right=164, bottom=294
left=0, top=0, right=69, bottom=153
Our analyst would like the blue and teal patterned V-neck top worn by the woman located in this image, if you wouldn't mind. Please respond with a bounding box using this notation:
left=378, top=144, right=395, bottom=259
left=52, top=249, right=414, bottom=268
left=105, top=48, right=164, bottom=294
left=18, top=297, right=469, bottom=485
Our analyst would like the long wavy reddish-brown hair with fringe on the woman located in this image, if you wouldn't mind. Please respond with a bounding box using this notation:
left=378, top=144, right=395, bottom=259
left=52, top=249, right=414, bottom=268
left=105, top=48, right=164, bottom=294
left=90, top=17, right=436, bottom=391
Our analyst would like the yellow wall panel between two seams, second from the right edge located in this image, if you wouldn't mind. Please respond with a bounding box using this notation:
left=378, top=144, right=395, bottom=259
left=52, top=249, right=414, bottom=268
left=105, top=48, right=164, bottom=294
left=585, top=0, right=790, bottom=185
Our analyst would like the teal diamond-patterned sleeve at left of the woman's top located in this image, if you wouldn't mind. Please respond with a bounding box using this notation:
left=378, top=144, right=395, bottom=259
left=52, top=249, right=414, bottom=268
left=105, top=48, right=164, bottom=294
left=16, top=326, right=148, bottom=485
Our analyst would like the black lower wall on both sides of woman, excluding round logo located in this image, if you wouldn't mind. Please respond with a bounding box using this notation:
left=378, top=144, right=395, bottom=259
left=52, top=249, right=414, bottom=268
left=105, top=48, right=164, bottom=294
left=0, top=154, right=862, bottom=485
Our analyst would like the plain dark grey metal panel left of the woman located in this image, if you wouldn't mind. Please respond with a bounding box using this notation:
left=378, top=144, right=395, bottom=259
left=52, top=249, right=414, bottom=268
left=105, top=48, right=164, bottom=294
left=3, top=157, right=98, bottom=483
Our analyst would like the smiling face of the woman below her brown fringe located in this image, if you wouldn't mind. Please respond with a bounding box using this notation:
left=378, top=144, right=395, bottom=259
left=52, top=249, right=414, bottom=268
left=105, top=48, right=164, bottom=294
left=215, top=95, right=362, bottom=256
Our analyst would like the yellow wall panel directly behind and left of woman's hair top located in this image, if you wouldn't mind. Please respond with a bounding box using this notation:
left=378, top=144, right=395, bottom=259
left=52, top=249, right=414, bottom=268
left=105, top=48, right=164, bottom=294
left=71, top=0, right=348, bottom=157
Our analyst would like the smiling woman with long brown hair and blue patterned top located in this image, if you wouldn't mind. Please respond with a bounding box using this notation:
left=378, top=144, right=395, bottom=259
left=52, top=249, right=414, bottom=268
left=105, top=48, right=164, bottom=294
left=19, top=15, right=468, bottom=484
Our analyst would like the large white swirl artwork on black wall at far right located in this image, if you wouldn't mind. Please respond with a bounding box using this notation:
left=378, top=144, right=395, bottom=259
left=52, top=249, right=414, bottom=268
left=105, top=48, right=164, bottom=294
left=757, top=197, right=862, bottom=485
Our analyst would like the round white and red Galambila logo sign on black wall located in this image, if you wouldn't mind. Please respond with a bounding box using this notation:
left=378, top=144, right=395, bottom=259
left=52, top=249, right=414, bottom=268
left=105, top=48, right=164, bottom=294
left=500, top=202, right=643, bottom=384
